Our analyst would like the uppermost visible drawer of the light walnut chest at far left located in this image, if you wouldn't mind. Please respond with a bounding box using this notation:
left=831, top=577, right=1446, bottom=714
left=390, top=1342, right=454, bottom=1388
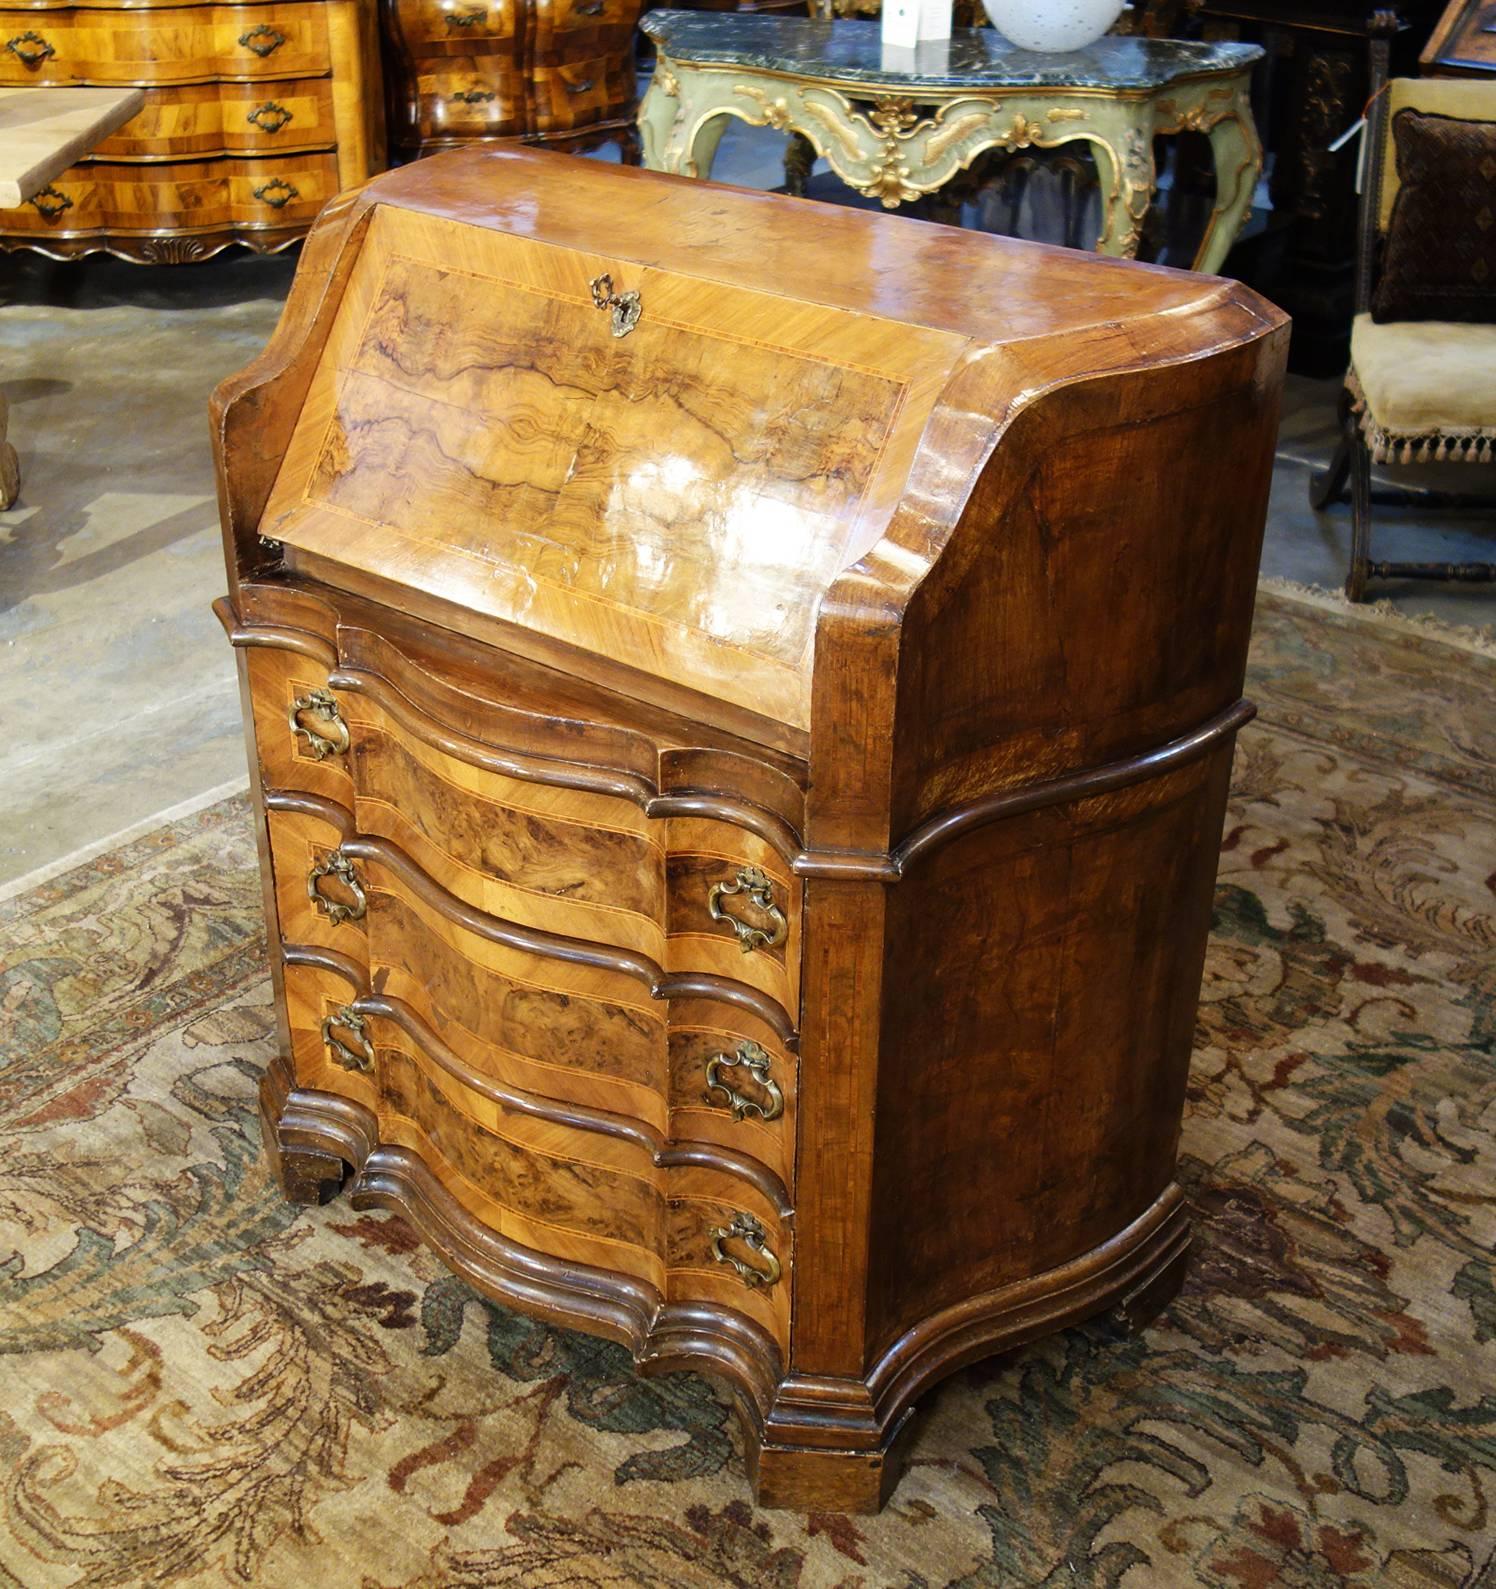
left=0, top=3, right=329, bottom=86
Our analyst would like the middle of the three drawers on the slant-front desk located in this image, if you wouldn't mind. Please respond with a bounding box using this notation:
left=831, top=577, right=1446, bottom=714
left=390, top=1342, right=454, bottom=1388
left=269, top=807, right=798, bottom=1185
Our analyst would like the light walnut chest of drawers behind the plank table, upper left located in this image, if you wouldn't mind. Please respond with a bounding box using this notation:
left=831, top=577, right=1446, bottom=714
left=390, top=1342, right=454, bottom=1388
left=0, top=0, right=385, bottom=264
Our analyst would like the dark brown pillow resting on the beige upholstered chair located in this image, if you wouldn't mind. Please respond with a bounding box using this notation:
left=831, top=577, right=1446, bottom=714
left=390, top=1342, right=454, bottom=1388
left=1372, top=110, right=1496, bottom=323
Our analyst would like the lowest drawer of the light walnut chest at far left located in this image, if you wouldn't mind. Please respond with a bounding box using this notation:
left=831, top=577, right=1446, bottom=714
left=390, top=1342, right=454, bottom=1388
left=0, top=149, right=337, bottom=235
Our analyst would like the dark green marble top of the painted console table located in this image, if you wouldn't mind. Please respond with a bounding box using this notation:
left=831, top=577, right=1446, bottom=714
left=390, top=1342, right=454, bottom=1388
left=639, top=11, right=1262, bottom=92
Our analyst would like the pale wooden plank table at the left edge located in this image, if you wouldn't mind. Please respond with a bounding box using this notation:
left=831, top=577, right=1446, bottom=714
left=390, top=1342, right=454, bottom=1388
left=0, top=87, right=145, bottom=510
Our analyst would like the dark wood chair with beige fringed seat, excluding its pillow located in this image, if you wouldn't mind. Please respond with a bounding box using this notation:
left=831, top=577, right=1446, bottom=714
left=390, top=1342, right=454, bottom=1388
left=1310, top=65, right=1496, bottom=601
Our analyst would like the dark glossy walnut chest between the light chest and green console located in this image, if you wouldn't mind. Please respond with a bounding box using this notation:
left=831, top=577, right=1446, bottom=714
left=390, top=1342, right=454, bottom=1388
left=382, top=0, right=639, bottom=159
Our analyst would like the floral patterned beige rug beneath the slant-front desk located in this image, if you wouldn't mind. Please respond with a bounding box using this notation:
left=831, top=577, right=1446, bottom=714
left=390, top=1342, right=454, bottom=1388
left=0, top=594, right=1496, bottom=1589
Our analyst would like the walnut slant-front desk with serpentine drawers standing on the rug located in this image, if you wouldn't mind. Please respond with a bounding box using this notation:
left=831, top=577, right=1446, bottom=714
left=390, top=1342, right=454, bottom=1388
left=215, top=148, right=1286, bottom=1510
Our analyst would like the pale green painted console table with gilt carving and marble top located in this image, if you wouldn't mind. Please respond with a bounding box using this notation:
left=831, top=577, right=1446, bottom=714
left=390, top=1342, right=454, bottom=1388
left=639, top=11, right=1262, bottom=272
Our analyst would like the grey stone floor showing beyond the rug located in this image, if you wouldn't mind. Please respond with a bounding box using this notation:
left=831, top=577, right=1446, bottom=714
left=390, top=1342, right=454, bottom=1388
left=0, top=127, right=1496, bottom=888
